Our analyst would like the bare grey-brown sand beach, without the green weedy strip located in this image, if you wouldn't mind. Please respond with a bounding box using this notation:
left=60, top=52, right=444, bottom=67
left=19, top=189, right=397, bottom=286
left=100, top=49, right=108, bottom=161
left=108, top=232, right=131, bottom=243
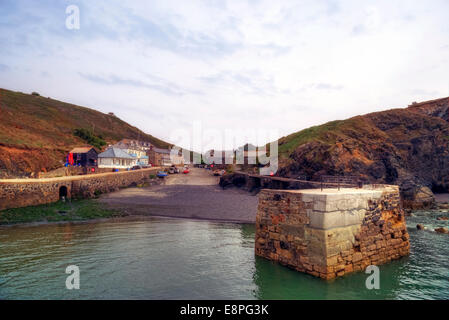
left=99, top=168, right=258, bottom=223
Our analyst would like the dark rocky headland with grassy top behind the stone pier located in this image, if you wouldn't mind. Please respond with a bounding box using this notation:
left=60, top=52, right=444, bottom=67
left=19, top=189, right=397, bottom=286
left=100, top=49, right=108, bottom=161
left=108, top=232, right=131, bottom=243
left=279, top=98, right=449, bottom=207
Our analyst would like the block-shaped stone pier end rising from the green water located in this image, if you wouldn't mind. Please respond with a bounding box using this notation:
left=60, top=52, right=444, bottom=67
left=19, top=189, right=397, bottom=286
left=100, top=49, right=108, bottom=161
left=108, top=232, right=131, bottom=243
left=255, top=185, right=410, bottom=279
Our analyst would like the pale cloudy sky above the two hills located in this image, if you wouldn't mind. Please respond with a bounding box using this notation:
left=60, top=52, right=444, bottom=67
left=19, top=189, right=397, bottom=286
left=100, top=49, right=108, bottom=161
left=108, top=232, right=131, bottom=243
left=0, top=0, right=449, bottom=148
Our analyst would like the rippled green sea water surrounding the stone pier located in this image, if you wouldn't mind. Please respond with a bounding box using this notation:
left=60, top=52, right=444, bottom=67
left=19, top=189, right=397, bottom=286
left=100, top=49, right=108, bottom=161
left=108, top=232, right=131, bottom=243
left=0, top=212, right=449, bottom=300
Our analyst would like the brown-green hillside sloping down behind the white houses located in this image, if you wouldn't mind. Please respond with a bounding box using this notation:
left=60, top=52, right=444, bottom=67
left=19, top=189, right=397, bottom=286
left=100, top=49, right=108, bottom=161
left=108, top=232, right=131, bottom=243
left=0, top=89, right=170, bottom=177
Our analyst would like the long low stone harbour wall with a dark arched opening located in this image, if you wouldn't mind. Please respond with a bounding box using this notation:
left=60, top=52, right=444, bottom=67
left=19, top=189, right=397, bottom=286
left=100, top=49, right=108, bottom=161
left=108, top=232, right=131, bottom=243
left=0, top=168, right=159, bottom=210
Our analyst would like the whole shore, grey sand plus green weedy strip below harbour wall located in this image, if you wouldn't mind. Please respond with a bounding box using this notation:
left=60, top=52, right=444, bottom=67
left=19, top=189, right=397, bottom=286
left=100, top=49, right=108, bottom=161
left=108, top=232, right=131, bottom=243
left=0, top=168, right=258, bottom=227
